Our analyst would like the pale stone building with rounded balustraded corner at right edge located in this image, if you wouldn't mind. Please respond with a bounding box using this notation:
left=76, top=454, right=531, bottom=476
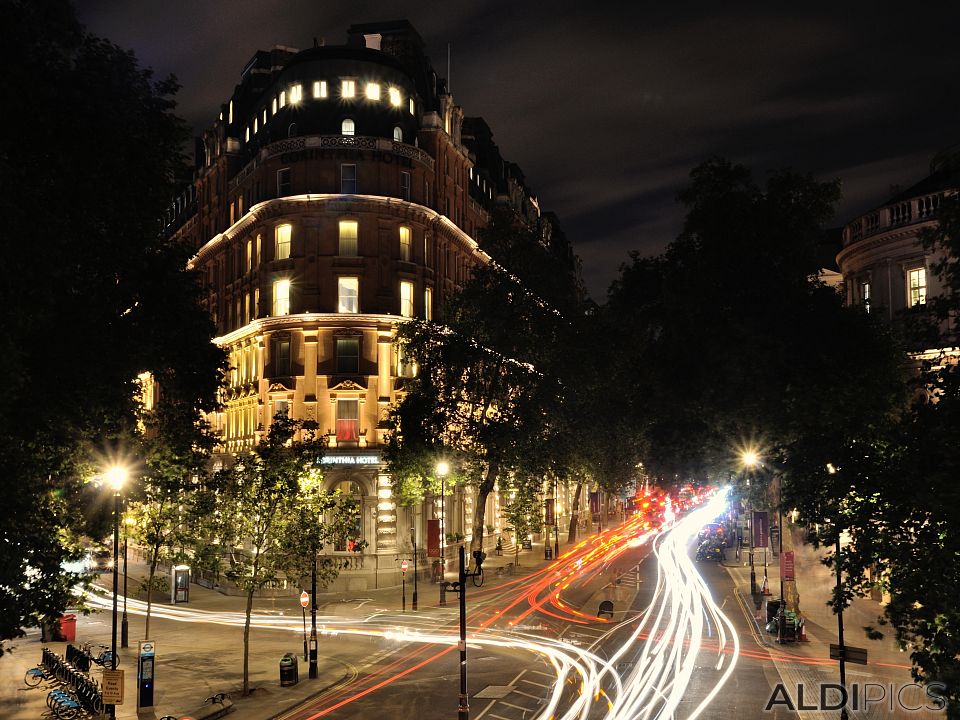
left=837, top=153, right=960, bottom=332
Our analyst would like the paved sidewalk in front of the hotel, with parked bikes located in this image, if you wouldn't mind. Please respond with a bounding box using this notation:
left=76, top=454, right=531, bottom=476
left=0, top=533, right=592, bottom=720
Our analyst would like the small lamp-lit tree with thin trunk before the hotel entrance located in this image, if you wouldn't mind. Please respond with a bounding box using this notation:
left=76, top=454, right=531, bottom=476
left=209, top=413, right=357, bottom=695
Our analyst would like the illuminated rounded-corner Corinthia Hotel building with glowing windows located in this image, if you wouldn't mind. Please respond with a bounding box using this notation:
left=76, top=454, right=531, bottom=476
left=167, top=21, right=572, bottom=590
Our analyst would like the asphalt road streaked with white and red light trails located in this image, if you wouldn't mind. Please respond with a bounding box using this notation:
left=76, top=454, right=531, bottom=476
left=65, top=496, right=936, bottom=720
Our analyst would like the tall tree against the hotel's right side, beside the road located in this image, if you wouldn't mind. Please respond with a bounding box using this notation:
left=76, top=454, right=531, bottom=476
left=387, top=213, right=578, bottom=550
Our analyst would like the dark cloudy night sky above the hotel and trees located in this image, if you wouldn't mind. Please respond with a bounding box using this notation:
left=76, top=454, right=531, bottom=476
left=78, top=0, right=960, bottom=301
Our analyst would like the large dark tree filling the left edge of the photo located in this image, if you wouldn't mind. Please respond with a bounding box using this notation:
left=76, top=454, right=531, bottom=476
left=0, top=0, right=223, bottom=651
